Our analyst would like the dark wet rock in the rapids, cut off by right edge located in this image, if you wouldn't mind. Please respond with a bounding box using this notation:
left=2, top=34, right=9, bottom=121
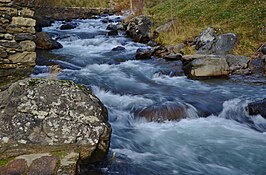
left=246, top=98, right=266, bottom=119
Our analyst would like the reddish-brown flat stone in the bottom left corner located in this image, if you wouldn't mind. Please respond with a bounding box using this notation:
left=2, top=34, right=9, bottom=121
left=0, top=159, right=28, bottom=175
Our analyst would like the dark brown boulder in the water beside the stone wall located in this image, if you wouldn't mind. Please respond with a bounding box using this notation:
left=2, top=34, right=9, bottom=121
left=34, top=32, right=63, bottom=50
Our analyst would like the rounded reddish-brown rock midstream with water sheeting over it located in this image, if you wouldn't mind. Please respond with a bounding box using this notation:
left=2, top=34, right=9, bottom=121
left=137, top=102, right=188, bottom=122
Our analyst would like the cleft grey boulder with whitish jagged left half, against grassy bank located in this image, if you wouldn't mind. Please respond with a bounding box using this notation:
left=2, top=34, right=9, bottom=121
left=194, top=28, right=238, bottom=55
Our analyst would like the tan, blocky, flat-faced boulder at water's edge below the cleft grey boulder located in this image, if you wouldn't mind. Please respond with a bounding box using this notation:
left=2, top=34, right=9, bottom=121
left=184, top=55, right=229, bottom=78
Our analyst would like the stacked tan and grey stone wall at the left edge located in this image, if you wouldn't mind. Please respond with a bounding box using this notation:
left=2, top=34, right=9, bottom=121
left=0, top=0, right=36, bottom=85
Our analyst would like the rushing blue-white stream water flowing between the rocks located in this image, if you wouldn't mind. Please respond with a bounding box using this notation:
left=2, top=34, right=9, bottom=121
left=32, top=16, right=266, bottom=175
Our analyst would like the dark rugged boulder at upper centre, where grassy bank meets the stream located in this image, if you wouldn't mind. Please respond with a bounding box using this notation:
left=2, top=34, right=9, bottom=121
left=126, top=15, right=153, bottom=43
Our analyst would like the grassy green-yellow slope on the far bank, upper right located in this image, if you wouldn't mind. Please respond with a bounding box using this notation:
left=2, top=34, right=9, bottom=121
left=145, top=0, right=266, bottom=55
